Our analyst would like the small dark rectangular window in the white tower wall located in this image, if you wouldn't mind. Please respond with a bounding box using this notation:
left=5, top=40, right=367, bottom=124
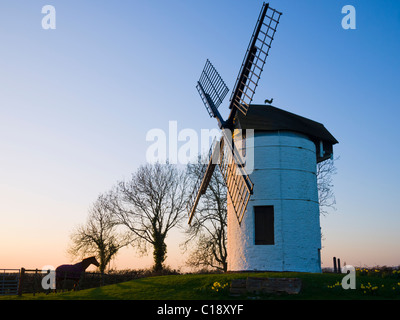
left=254, top=206, right=275, bottom=245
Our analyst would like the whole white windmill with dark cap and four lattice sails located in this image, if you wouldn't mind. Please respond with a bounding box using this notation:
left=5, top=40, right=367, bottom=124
left=188, top=3, right=337, bottom=272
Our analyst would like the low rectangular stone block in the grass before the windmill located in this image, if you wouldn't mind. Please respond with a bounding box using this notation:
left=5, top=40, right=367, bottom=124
left=230, top=277, right=301, bottom=295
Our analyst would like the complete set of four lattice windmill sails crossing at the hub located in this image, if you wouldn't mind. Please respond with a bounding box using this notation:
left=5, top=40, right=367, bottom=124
left=188, top=3, right=282, bottom=224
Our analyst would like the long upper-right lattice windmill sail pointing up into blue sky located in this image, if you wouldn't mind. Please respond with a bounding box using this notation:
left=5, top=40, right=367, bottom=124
left=229, top=3, right=282, bottom=120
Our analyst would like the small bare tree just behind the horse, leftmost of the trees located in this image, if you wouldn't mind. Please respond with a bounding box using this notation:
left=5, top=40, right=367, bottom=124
left=68, top=195, right=132, bottom=273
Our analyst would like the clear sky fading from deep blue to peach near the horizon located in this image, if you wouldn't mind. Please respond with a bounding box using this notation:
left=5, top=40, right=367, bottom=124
left=0, top=0, right=400, bottom=268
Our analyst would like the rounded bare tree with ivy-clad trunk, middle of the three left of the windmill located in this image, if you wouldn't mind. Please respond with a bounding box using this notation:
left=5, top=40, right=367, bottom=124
left=110, top=163, right=187, bottom=271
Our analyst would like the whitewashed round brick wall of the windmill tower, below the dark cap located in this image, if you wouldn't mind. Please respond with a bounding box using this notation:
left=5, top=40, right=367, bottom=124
left=228, top=132, right=321, bottom=272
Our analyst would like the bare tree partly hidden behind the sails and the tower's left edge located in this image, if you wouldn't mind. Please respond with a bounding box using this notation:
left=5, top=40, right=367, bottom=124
left=183, top=160, right=228, bottom=272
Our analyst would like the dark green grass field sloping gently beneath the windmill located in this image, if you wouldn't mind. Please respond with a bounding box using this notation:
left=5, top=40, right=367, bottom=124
left=0, top=272, right=400, bottom=300
